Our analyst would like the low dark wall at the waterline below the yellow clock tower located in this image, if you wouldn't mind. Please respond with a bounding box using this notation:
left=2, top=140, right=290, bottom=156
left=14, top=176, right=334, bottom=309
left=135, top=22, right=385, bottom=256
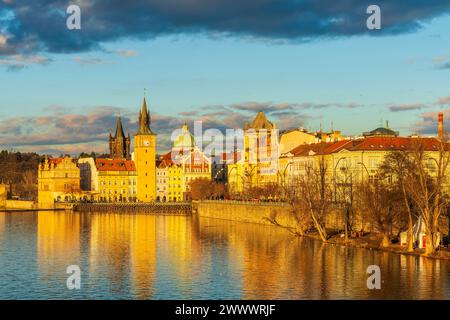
left=73, top=202, right=192, bottom=216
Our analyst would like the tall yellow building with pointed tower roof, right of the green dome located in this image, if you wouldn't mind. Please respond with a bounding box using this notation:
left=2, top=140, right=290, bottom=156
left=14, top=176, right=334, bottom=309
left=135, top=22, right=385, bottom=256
left=228, top=111, right=279, bottom=193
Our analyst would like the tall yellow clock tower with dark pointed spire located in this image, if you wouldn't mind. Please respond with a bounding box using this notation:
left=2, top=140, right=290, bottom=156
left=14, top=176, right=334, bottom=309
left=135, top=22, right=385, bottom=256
left=134, top=97, right=156, bottom=202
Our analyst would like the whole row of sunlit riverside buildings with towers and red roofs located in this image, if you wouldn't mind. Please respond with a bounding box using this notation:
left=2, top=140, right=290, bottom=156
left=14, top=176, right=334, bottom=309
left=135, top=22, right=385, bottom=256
left=38, top=98, right=444, bottom=206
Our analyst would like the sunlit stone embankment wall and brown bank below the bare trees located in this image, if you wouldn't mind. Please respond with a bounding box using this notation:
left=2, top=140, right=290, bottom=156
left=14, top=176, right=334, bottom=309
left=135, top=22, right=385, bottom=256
left=193, top=201, right=450, bottom=260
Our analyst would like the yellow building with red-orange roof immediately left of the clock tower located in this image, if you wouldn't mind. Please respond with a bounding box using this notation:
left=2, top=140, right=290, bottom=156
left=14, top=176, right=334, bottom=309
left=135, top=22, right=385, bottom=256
left=95, top=159, right=137, bottom=202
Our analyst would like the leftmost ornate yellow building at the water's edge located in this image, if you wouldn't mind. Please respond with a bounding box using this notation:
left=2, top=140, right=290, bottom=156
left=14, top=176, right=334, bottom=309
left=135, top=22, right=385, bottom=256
left=38, top=157, right=82, bottom=208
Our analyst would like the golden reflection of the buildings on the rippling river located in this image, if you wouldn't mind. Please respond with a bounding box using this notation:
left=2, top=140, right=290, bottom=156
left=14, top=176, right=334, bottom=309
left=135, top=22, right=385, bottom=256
left=29, top=212, right=450, bottom=299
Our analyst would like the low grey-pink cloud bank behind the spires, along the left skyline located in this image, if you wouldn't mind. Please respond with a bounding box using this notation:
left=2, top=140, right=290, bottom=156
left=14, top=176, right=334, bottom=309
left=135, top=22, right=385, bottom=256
left=0, top=102, right=309, bottom=155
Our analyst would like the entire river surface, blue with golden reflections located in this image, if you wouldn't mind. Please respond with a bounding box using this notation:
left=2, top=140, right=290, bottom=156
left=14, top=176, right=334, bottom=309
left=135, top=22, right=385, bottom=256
left=0, top=212, right=450, bottom=299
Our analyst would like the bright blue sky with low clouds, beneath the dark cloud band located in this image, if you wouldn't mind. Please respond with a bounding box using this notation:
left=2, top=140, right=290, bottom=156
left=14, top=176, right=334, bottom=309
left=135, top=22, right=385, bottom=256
left=0, top=0, right=450, bottom=153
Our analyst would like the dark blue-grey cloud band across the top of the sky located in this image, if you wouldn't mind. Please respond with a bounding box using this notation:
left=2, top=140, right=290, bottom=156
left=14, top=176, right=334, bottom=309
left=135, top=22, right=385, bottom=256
left=0, top=0, right=450, bottom=55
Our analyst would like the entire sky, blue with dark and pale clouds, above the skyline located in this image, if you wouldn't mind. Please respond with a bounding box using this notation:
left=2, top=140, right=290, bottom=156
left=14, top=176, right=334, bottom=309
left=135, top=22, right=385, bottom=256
left=0, top=0, right=450, bottom=154
